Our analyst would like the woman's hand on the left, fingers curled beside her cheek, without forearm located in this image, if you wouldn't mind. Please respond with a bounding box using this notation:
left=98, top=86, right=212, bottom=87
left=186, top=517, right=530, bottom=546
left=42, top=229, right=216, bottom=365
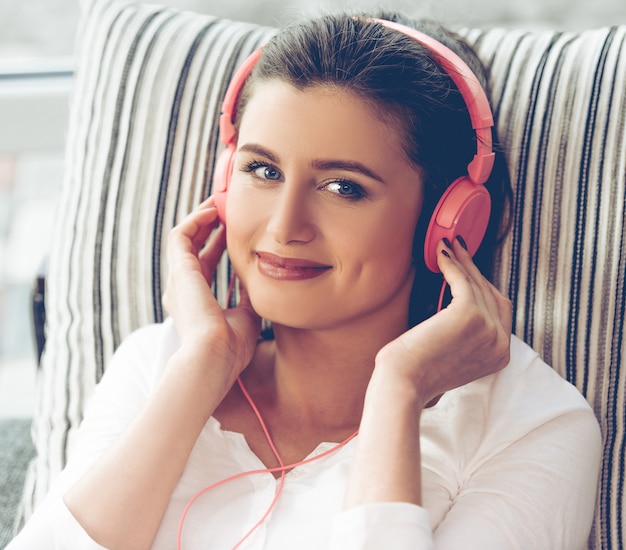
left=163, top=197, right=261, bottom=384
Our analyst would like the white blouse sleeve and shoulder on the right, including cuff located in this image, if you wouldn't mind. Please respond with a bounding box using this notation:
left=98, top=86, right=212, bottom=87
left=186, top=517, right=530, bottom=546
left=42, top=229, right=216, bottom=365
left=331, top=341, right=602, bottom=550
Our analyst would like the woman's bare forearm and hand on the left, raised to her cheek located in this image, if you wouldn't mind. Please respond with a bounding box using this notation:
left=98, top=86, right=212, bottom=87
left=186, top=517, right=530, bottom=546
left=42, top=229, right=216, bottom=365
left=65, top=204, right=259, bottom=549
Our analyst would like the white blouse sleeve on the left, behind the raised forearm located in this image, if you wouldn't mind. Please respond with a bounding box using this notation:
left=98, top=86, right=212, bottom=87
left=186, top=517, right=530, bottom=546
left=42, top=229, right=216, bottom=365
left=7, top=325, right=175, bottom=550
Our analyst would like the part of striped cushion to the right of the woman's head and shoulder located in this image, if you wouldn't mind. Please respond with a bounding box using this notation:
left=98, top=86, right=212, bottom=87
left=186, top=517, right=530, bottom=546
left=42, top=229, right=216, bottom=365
left=466, top=26, right=626, bottom=549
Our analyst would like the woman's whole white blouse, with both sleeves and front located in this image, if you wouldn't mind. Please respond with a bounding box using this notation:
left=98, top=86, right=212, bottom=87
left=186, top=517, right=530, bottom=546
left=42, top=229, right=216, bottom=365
left=7, top=320, right=601, bottom=550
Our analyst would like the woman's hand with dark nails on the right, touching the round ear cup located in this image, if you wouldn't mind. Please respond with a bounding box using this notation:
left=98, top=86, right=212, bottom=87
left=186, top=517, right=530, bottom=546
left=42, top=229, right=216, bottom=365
left=374, top=241, right=512, bottom=412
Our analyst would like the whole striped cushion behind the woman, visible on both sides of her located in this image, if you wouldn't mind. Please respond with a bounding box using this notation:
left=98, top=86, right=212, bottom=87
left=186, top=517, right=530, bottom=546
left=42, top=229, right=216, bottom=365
left=21, top=0, right=626, bottom=548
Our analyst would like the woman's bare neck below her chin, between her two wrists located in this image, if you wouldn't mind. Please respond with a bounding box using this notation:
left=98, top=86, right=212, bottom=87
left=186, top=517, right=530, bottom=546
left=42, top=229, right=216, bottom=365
left=243, top=268, right=412, bottom=441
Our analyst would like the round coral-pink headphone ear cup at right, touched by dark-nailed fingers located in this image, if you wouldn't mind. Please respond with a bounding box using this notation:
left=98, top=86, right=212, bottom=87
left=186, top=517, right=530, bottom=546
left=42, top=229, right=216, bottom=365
left=424, top=176, right=491, bottom=273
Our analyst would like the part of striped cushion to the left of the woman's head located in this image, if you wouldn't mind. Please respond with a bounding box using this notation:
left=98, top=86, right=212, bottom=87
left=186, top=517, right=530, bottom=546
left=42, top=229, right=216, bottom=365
left=15, top=0, right=275, bottom=536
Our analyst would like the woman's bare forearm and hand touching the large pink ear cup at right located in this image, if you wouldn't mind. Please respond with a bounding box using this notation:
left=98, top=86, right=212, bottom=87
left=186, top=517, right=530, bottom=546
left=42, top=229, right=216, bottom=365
left=345, top=242, right=511, bottom=508
